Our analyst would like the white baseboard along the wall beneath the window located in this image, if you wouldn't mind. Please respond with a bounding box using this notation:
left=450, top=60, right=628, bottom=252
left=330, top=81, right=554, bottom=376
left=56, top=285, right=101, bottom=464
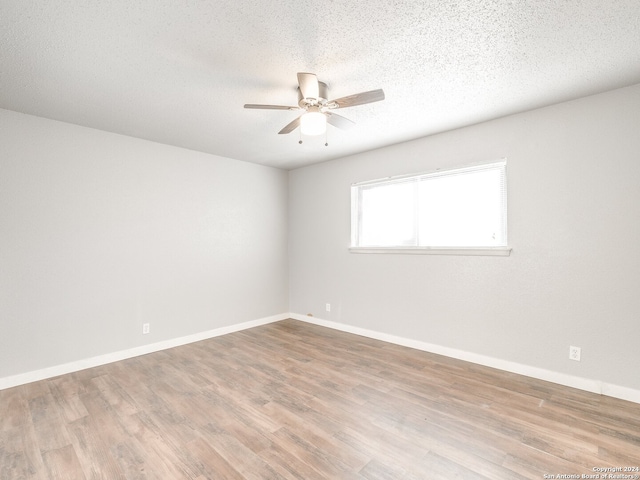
left=289, top=313, right=640, bottom=403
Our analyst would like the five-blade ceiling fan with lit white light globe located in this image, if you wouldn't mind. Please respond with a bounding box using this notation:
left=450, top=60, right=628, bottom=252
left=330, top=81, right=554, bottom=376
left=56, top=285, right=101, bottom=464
left=244, top=73, right=384, bottom=143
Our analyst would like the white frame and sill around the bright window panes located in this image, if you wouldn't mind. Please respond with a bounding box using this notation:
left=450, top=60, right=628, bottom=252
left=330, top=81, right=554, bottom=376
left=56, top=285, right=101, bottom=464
left=349, top=159, right=511, bottom=256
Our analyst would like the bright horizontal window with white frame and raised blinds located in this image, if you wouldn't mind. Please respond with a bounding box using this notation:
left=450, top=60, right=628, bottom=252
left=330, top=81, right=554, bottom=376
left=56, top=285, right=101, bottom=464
left=351, top=161, right=509, bottom=255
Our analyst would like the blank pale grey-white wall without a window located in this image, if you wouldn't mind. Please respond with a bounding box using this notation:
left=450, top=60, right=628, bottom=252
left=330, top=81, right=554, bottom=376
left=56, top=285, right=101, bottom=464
left=0, top=110, right=288, bottom=379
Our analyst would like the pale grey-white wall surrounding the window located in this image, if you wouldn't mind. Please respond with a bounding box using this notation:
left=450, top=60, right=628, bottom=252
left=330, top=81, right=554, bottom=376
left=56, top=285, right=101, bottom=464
left=289, top=85, right=640, bottom=391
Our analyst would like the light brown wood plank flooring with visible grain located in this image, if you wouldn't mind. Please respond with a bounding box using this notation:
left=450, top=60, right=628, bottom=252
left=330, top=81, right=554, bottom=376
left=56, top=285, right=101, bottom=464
left=0, top=320, right=640, bottom=480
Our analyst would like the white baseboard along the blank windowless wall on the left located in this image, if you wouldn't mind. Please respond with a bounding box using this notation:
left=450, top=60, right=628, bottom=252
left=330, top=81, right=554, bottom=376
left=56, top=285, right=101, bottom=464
left=0, top=313, right=290, bottom=390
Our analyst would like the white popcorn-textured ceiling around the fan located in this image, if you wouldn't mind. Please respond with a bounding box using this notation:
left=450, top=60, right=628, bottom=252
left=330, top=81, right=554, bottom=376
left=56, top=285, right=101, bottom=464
left=0, top=0, right=640, bottom=168
